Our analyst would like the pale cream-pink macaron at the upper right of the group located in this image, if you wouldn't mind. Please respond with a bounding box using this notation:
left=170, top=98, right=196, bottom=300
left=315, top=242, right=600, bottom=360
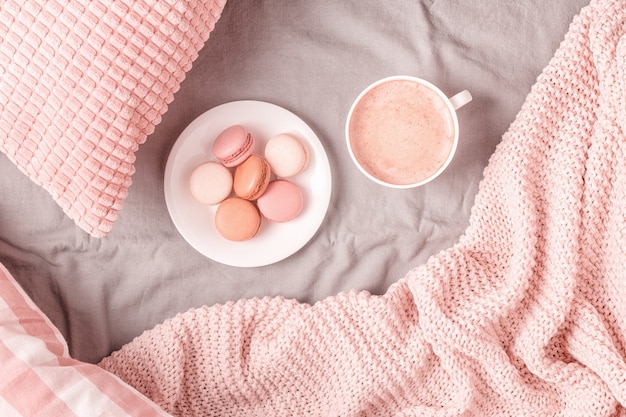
left=264, top=133, right=309, bottom=178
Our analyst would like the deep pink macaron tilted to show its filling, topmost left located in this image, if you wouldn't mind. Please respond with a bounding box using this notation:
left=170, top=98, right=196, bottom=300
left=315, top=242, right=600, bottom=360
left=213, top=125, right=255, bottom=168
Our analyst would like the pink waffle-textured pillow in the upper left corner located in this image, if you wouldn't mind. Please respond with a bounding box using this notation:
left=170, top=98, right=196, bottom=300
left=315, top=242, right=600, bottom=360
left=0, top=0, right=226, bottom=237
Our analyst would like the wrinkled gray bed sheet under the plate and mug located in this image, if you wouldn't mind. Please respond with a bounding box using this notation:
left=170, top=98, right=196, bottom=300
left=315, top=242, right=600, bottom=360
left=0, top=0, right=588, bottom=362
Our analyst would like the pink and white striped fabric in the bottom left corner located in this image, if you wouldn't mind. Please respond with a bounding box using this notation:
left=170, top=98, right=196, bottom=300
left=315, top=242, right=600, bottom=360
left=0, top=264, right=169, bottom=417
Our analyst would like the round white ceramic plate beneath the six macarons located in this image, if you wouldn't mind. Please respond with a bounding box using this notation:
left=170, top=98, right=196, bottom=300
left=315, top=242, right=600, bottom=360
left=164, top=101, right=332, bottom=267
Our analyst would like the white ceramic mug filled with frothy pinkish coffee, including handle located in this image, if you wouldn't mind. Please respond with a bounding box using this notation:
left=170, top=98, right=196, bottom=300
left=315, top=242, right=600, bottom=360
left=346, top=75, right=472, bottom=188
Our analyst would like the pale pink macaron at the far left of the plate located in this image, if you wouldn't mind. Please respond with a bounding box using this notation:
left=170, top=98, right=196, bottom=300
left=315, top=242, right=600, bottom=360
left=189, top=162, right=233, bottom=205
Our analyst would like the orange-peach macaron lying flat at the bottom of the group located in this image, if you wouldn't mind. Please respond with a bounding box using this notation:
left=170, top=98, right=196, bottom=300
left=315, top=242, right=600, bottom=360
left=214, top=197, right=261, bottom=242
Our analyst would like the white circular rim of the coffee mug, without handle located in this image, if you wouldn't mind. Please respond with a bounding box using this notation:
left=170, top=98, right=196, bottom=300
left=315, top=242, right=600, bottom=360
left=345, top=75, right=459, bottom=189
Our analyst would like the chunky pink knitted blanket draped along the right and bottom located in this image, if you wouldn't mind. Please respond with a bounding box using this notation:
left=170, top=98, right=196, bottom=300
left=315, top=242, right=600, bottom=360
left=100, top=0, right=626, bottom=416
